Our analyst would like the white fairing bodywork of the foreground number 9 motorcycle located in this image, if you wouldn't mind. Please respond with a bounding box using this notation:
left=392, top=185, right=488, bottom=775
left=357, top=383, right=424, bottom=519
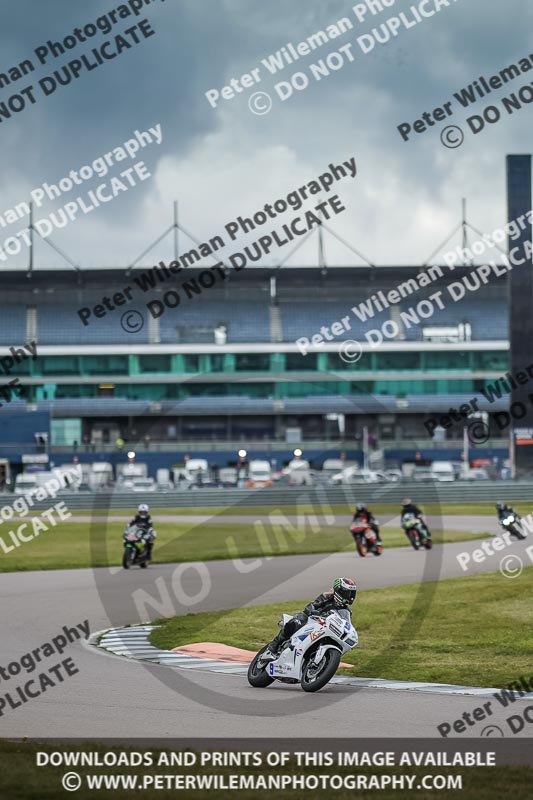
left=266, top=609, right=359, bottom=681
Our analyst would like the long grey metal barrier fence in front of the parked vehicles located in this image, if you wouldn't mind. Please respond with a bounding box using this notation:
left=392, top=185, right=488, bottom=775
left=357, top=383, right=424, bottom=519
left=0, top=481, right=533, bottom=511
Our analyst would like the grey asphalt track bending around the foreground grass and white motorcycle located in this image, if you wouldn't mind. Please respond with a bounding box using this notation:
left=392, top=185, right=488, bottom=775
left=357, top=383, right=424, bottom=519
left=0, top=517, right=533, bottom=740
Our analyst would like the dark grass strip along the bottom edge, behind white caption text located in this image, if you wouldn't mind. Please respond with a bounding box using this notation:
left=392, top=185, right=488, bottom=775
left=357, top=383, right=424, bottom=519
left=0, top=740, right=533, bottom=800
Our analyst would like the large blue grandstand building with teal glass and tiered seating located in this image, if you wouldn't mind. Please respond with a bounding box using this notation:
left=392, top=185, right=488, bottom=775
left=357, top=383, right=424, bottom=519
left=0, top=267, right=509, bottom=476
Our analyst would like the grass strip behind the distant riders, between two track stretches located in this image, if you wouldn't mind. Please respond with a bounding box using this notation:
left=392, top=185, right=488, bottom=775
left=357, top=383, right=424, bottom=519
left=0, top=517, right=484, bottom=572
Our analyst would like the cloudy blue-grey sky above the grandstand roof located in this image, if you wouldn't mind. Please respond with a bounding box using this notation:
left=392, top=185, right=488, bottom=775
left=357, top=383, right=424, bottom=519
left=0, top=0, right=533, bottom=269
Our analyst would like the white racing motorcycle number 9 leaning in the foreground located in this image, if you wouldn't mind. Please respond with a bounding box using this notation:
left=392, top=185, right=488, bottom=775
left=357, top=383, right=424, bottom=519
left=248, top=608, right=359, bottom=692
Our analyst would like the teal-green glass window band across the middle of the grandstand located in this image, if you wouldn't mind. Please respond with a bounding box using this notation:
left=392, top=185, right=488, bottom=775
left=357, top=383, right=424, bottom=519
left=23, top=349, right=508, bottom=401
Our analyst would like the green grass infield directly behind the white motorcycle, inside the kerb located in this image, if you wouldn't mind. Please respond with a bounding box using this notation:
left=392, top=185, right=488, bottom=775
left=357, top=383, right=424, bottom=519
left=151, top=567, right=533, bottom=687
